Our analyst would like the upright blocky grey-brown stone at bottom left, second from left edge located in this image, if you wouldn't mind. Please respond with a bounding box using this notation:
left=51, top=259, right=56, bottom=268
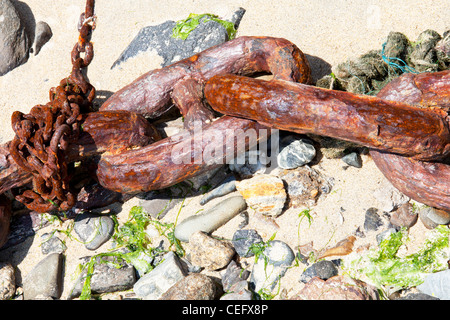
left=23, top=253, right=63, bottom=300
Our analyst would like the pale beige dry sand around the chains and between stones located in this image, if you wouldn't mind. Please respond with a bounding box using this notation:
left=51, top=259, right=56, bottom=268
left=0, top=0, right=450, bottom=298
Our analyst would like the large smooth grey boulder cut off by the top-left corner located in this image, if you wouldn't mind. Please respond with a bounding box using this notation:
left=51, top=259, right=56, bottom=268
left=0, top=0, right=30, bottom=76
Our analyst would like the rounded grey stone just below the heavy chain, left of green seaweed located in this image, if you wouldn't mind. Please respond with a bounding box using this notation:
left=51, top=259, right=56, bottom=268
left=73, top=213, right=114, bottom=250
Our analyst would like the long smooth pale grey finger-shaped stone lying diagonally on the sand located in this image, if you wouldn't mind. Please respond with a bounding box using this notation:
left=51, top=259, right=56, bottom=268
left=174, top=196, right=247, bottom=242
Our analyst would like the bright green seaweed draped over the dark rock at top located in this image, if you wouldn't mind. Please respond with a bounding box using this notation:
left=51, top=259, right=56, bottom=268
left=172, top=13, right=236, bottom=40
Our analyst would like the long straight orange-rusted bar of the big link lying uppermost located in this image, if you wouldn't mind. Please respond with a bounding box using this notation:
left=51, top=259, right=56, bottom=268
left=204, top=75, right=450, bottom=160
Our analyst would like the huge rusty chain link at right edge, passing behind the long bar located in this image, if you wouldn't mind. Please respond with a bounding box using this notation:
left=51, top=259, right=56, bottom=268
left=370, top=71, right=450, bottom=210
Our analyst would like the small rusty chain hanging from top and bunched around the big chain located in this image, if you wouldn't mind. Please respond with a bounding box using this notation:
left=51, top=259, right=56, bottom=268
left=10, top=0, right=96, bottom=212
